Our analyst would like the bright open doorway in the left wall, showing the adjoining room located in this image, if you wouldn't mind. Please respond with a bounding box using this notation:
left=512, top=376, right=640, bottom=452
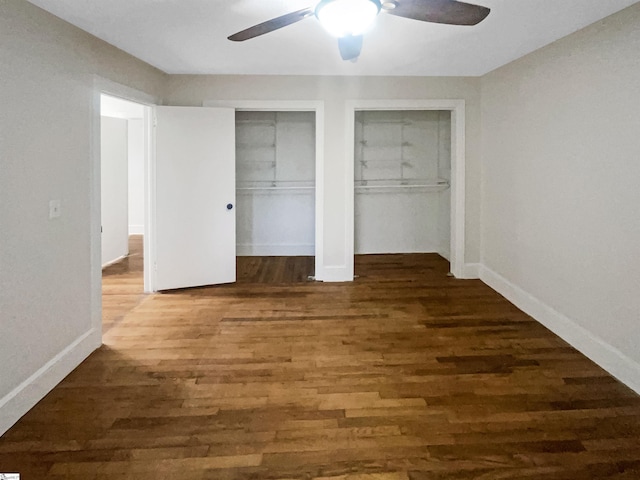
left=100, top=94, right=147, bottom=333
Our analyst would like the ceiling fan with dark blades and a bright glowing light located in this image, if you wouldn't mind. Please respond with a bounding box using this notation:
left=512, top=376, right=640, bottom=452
left=228, top=0, right=490, bottom=61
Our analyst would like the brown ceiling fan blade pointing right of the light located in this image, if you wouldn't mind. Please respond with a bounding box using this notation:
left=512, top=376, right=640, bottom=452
left=387, top=0, right=491, bottom=25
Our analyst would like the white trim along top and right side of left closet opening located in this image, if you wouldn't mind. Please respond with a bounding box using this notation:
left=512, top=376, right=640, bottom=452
left=202, top=100, right=325, bottom=281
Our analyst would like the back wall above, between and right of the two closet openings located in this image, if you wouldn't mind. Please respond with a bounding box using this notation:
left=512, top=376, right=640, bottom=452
left=165, top=75, right=480, bottom=278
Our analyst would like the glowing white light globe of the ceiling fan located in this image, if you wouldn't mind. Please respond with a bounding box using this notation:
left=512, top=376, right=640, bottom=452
left=315, top=0, right=381, bottom=38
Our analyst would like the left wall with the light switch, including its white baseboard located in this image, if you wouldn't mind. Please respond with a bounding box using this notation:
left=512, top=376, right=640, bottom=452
left=0, top=0, right=165, bottom=433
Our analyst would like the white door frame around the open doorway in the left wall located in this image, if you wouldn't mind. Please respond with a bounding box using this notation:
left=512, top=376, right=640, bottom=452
left=89, top=75, right=159, bottom=335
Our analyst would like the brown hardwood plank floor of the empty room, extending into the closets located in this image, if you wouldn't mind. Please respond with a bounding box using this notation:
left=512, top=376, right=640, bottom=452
left=0, top=249, right=640, bottom=480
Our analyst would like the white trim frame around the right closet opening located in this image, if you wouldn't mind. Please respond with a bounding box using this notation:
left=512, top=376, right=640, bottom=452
left=345, top=99, right=467, bottom=278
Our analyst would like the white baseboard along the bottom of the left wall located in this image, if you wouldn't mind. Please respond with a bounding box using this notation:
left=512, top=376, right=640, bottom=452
left=0, top=329, right=102, bottom=435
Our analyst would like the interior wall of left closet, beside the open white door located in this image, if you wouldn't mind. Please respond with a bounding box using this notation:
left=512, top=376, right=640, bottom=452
left=236, top=111, right=316, bottom=255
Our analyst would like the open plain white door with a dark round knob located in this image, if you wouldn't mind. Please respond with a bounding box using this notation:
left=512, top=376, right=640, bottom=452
left=155, top=107, right=236, bottom=290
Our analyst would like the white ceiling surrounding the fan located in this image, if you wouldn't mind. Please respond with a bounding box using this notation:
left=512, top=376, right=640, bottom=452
left=30, top=0, right=638, bottom=76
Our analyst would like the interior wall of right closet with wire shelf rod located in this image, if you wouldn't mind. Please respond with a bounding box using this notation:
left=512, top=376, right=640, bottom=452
left=354, top=110, right=451, bottom=259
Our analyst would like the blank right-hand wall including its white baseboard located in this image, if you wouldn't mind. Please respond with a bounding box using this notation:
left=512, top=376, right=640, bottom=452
left=482, top=4, right=640, bottom=391
